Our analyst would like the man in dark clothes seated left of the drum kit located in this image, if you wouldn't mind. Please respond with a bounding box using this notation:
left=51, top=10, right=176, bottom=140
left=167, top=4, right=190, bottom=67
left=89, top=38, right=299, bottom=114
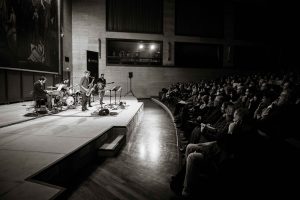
left=33, top=76, right=51, bottom=110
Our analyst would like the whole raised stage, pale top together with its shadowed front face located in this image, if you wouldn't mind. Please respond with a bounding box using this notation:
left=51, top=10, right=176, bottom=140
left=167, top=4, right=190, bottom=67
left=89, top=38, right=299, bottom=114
left=0, top=96, right=143, bottom=199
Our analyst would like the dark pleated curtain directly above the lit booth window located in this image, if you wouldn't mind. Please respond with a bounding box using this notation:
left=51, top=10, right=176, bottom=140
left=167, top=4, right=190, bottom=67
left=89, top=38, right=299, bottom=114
left=106, top=0, right=163, bottom=33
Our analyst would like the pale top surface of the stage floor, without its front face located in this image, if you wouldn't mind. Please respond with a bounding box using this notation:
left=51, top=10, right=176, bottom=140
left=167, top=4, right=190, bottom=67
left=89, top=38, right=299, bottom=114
left=0, top=97, right=143, bottom=199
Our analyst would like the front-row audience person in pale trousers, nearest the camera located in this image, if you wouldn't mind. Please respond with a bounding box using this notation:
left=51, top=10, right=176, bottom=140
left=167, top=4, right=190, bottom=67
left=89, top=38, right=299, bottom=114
left=182, top=108, right=256, bottom=197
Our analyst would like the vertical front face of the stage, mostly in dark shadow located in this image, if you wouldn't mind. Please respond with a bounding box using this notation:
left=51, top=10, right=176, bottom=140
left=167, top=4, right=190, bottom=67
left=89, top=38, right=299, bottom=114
left=26, top=105, right=143, bottom=198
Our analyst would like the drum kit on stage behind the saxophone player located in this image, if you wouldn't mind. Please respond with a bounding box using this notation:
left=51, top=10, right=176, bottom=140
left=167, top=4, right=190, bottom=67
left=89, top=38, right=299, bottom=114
left=46, top=83, right=81, bottom=108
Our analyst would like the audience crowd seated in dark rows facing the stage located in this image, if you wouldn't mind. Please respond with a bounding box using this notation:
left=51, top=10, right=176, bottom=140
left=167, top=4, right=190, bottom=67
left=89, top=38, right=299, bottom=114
left=160, top=73, right=300, bottom=197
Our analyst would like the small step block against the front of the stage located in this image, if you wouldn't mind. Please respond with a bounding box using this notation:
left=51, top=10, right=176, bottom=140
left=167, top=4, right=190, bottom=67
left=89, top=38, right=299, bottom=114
left=98, top=135, right=126, bottom=157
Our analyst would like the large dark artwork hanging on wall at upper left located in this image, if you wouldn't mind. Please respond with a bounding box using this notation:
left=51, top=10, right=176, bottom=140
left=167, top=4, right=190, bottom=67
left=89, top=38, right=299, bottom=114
left=0, top=0, right=59, bottom=72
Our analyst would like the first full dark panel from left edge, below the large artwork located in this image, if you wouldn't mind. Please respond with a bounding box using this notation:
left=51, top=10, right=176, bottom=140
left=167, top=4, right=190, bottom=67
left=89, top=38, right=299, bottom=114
left=7, top=70, right=22, bottom=102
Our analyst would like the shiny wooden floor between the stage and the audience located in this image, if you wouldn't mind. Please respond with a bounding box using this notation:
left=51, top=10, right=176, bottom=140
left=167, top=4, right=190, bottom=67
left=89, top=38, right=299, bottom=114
left=69, top=100, right=178, bottom=200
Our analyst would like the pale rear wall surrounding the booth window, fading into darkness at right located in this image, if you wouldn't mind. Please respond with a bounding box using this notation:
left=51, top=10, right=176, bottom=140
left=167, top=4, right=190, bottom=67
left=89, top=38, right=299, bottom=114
left=72, top=0, right=296, bottom=97
